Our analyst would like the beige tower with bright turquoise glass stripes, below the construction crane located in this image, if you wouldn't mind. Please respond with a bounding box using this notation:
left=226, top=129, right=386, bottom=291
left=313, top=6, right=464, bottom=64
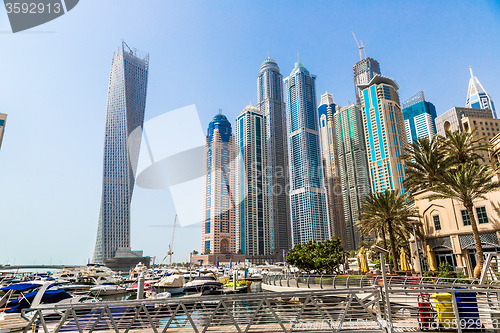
left=359, top=75, right=408, bottom=193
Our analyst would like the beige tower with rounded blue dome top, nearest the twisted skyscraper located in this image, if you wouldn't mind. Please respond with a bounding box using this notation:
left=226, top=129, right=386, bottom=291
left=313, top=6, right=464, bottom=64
left=201, top=113, right=236, bottom=254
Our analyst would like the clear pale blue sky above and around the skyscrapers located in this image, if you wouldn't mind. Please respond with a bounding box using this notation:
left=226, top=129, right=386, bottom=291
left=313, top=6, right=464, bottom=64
left=0, top=0, right=500, bottom=264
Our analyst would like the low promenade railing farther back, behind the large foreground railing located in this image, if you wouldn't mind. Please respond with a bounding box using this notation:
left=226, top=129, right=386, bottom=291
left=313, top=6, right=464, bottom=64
left=262, top=274, right=494, bottom=289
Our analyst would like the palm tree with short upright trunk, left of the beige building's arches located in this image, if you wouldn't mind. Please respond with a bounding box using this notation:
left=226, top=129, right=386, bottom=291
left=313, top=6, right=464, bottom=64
left=357, top=190, right=418, bottom=269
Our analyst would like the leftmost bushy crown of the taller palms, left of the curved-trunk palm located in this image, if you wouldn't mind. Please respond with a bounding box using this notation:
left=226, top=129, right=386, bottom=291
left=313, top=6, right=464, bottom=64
left=401, top=135, right=449, bottom=194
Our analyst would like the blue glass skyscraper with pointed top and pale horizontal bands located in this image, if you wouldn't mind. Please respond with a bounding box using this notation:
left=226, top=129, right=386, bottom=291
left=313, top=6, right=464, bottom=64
left=285, top=62, right=329, bottom=245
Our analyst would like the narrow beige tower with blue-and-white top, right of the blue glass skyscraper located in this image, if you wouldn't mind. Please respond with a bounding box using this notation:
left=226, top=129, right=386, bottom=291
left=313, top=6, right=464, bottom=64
left=318, top=92, right=347, bottom=248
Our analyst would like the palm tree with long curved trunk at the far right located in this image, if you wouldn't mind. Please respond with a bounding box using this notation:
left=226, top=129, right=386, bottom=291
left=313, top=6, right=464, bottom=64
left=427, top=161, right=500, bottom=278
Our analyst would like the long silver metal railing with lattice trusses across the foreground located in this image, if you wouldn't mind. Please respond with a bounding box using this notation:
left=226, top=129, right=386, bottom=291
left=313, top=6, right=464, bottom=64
left=23, top=285, right=500, bottom=333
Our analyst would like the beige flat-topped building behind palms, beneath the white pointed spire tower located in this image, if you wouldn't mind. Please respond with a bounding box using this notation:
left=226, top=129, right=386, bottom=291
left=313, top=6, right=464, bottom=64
left=436, top=107, right=493, bottom=136
